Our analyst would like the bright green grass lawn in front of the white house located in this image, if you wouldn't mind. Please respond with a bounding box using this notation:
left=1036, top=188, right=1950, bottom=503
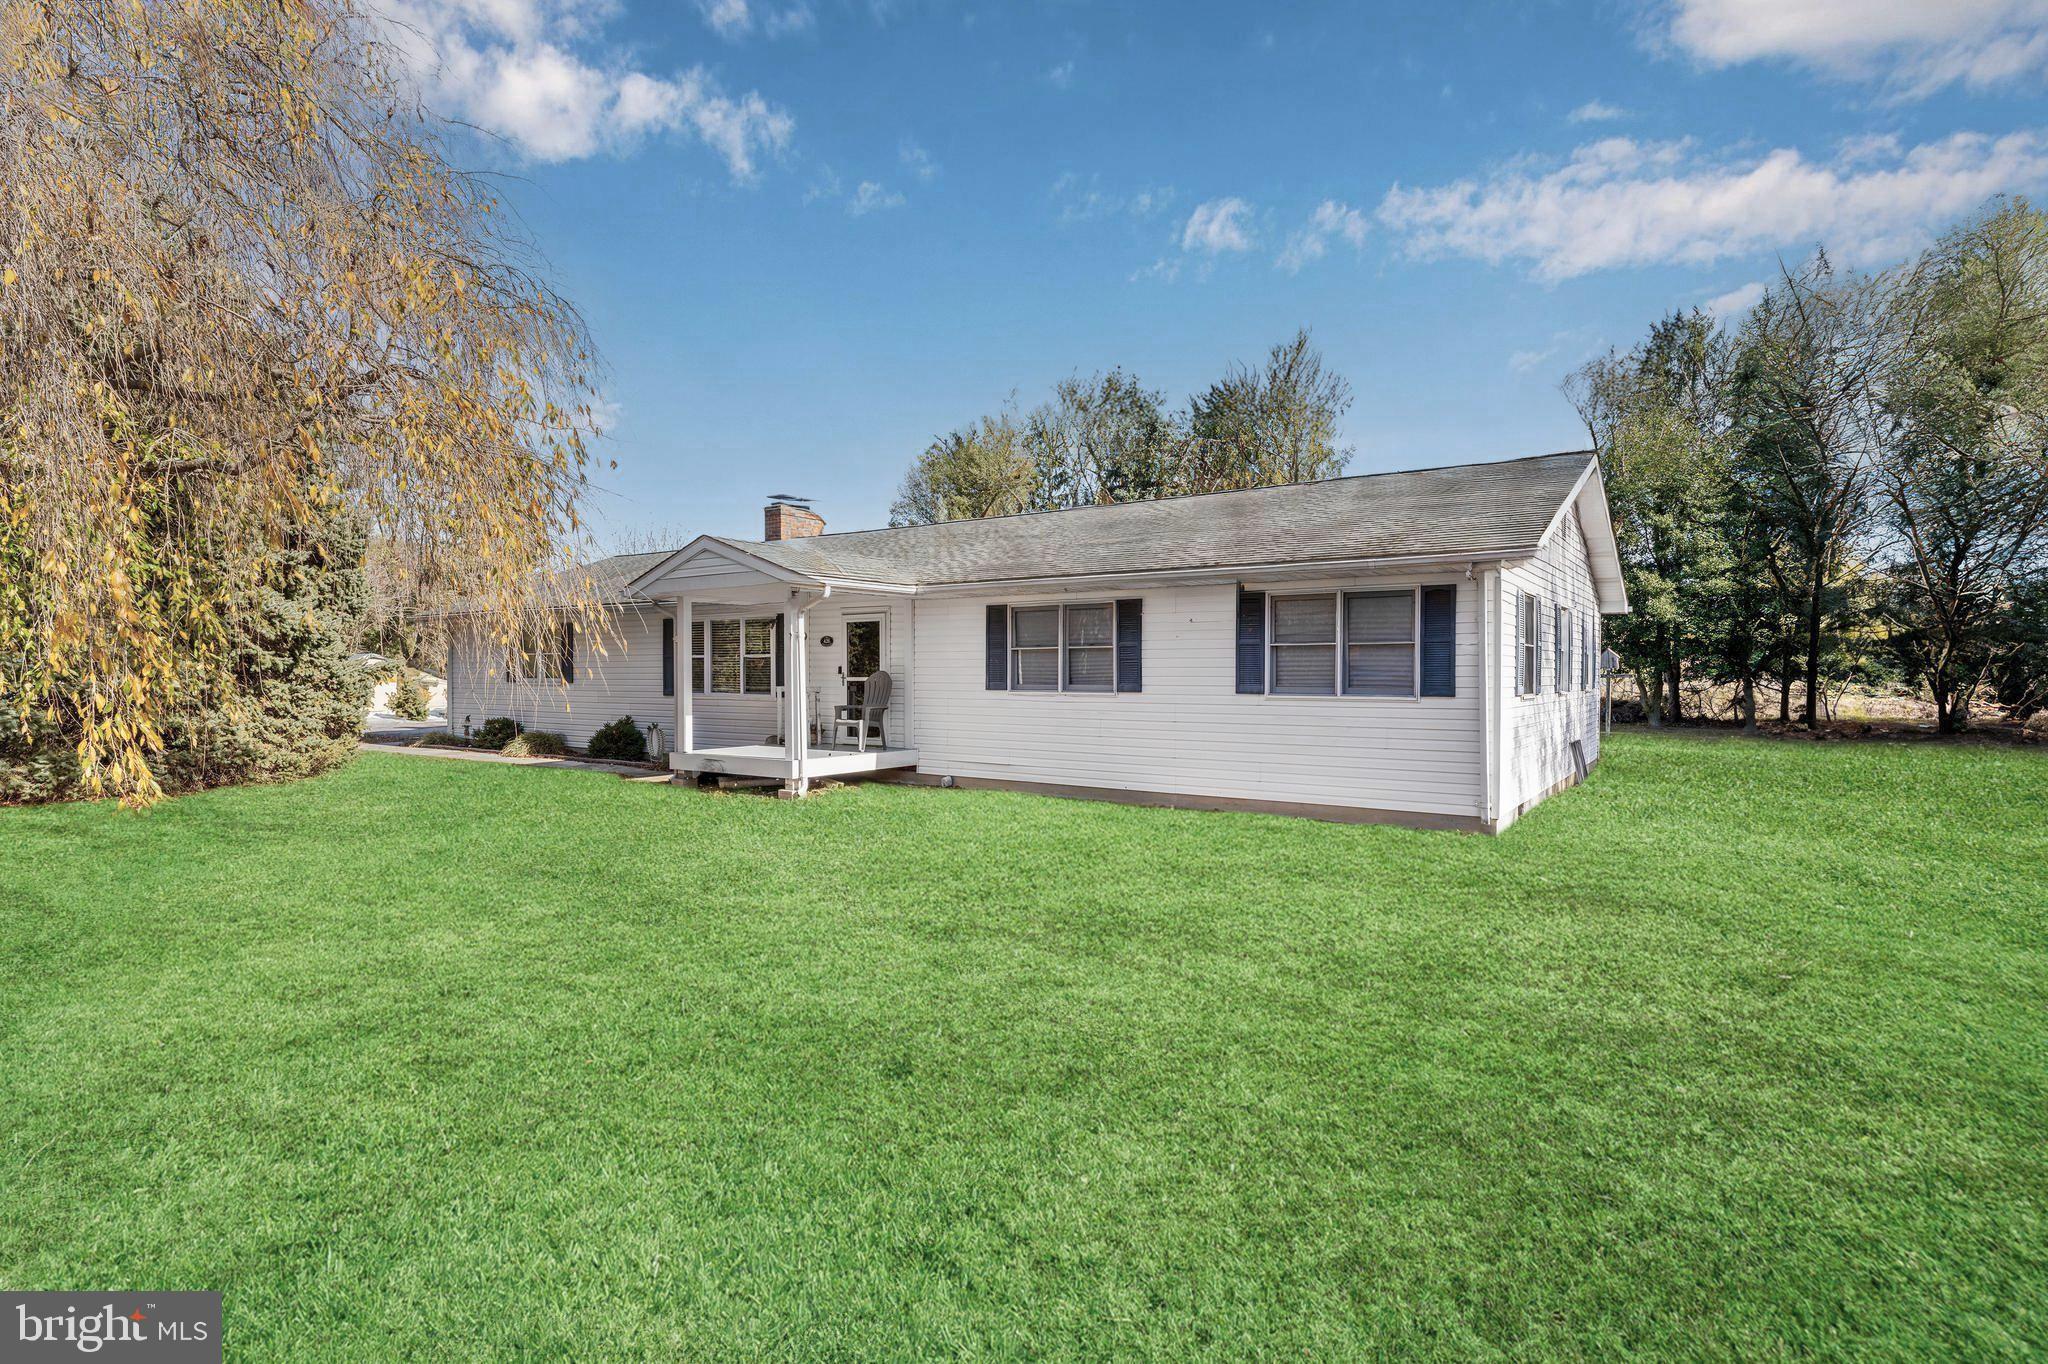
left=0, top=737, right=2048, bottom=1360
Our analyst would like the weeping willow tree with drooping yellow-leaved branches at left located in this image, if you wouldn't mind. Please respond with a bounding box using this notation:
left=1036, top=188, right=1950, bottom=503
left=0, top=0, right=598, bottom=805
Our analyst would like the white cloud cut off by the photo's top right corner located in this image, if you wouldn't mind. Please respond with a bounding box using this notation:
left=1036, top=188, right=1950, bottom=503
left=1663, top=0, right=2048, bottom=98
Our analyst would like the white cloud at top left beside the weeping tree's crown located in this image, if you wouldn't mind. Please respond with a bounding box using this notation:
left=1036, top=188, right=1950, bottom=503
left=381, top=0, right=797, bottom=182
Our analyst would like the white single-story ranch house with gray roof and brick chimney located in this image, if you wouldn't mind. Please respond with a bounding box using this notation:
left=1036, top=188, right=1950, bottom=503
left=449, top=451, right=1628, bottom=832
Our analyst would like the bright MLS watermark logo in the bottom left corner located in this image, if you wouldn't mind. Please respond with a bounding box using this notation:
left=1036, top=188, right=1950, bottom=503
left=0, top=1292, right=221, bottom=1364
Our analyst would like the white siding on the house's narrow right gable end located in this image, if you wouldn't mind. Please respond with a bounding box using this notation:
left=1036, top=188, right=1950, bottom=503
left=1499, top=499, right=1599, bottom=825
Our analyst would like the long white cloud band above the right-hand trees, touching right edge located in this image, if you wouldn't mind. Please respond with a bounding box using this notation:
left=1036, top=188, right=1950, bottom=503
left=1378, top=131, right=2048, bottom=281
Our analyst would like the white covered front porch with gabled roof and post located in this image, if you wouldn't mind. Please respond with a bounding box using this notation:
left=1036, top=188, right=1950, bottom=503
left=633, top=537, right=918, bottom=797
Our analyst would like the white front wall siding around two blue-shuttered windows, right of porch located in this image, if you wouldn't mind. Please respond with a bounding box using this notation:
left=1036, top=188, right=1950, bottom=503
left=915, top=567, right=1483, bottom=817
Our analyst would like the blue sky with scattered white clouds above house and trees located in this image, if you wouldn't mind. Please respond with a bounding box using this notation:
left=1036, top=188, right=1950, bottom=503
left=385, top=0, right=2048, bottom=537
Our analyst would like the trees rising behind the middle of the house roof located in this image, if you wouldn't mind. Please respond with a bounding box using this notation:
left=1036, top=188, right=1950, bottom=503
left=889, top=330, right=1352, bottom=526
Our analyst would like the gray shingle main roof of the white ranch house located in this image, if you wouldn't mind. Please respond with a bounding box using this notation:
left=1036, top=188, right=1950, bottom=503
left=590, top=451, right=1593, bottom=596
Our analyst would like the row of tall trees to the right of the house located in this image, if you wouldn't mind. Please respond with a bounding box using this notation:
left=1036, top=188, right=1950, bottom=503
left=1565, top=199, right=2048, bottom=733
